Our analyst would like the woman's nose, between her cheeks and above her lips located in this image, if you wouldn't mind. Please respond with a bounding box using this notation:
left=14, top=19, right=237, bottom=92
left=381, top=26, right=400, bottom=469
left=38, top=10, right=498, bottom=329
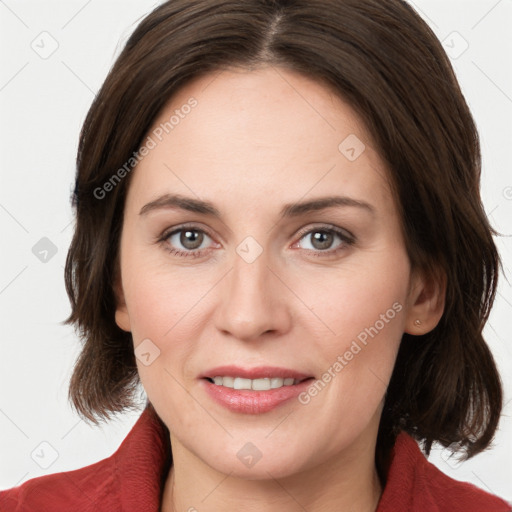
left=216, top=249, right=292, bottom=341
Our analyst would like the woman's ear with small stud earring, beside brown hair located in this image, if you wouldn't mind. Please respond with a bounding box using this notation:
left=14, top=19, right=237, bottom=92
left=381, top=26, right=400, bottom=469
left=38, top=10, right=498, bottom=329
left=405, top=271, right=446, bottom=336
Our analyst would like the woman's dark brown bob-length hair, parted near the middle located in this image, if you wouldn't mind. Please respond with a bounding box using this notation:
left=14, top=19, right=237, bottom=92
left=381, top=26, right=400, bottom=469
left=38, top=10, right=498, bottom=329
left=65, top=0, right=502, bottom=460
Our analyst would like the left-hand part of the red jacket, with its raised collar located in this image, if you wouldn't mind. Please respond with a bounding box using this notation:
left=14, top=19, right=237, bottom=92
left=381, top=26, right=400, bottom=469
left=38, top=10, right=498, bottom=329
left=0, top=404, right=172, bottom=512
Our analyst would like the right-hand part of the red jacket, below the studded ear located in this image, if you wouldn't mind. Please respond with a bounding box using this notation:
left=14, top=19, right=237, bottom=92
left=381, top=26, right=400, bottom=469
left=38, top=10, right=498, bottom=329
left=377, top=433, right=512, bottom=512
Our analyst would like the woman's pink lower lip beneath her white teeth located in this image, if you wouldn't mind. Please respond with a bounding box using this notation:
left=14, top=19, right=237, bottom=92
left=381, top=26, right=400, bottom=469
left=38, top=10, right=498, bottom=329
left=202, top=378, right=313, bottom=414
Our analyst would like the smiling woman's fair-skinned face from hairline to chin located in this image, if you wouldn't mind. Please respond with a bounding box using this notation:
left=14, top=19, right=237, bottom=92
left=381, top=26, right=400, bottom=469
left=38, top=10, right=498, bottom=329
left=116, top=67, right=428, bottom=479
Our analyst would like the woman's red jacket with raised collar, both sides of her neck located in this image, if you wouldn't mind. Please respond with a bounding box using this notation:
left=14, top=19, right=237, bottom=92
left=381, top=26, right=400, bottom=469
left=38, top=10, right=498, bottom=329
left=0, top=409, right=512, bottom=512
